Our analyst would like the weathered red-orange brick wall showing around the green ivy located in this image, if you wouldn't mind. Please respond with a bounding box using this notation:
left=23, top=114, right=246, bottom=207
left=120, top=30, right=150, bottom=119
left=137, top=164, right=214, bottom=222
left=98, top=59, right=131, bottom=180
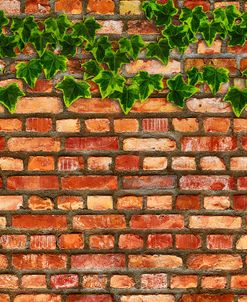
left=0, top=0, right=247, bottom=302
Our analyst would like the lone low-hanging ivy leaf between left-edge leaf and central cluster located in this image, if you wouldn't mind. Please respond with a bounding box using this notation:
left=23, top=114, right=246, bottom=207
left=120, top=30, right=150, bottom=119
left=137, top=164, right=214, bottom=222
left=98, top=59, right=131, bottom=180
left=56, top=76, right=91, bottom=107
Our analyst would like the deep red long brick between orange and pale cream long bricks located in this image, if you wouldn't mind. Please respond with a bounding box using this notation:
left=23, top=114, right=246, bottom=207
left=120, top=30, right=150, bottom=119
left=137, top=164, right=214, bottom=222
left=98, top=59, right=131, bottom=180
left=65, top=137, right=118, bottom=151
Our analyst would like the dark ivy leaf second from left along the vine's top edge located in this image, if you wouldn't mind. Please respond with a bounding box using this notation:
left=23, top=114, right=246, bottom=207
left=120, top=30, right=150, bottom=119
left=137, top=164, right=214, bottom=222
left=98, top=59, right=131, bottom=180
left=10, top=16, right=39, bottom=43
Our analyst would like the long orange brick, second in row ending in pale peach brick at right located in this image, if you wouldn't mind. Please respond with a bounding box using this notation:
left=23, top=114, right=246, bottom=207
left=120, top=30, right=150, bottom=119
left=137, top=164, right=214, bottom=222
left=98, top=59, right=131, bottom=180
left=73, top=214, right=125, bottom=230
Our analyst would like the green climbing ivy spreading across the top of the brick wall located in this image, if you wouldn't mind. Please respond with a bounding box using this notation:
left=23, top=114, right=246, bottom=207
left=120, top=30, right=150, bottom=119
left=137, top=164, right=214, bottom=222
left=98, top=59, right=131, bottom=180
left=0, top=0, right=247, bottom=116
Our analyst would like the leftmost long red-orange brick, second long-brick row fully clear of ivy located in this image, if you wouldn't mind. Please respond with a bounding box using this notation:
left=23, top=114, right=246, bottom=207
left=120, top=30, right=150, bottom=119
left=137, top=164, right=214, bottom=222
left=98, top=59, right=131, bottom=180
left=7, top=176, right=59, bottom=190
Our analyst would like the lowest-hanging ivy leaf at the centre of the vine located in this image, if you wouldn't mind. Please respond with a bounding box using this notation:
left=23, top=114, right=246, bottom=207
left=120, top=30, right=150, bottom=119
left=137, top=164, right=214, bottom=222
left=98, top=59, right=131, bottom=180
left=110, top=85, right=139, bottom=114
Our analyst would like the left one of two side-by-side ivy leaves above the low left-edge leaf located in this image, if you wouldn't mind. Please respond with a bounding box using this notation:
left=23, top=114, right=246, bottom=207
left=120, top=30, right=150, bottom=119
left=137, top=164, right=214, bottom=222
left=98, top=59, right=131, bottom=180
left=16, top=59, right=42, bottom=88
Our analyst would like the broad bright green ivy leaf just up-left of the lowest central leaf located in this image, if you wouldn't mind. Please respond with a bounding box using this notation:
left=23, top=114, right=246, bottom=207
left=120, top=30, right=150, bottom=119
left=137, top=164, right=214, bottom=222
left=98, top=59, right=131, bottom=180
left=93, top=70, right=125, bottom=99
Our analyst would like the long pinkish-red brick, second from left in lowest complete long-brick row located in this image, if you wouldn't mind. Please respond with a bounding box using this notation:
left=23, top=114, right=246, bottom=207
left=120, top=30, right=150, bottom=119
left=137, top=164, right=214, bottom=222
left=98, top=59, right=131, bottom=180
left=71, top=254, right=125, bottom=270
